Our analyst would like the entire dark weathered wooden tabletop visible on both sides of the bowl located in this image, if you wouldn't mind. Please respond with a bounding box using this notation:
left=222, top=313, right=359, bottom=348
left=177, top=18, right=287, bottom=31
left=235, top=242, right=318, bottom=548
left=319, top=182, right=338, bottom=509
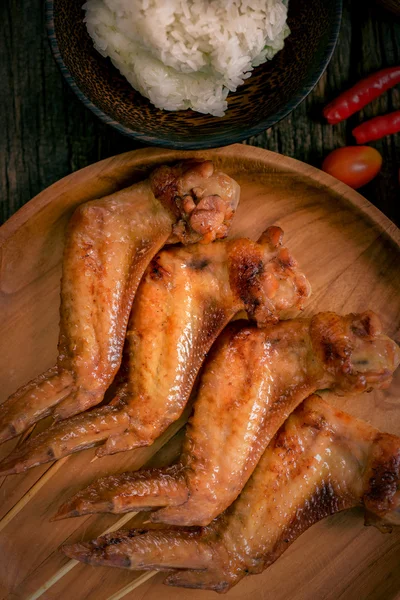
left=0, top=0, right=400, bottom=225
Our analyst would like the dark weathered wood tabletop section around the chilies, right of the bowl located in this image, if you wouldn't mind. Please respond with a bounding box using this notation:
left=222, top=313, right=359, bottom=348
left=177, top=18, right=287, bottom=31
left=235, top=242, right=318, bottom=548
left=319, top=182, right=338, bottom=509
left=248, top=1, right=400, bottom=224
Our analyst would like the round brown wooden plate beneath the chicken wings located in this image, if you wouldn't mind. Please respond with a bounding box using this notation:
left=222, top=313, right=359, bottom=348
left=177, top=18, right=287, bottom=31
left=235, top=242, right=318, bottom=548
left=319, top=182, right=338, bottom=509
left=0, top=145, right=400, bottom=600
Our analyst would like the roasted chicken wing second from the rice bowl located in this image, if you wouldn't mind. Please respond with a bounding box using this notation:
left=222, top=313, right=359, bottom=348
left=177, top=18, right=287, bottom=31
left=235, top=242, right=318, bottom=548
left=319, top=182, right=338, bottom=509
left=0, top=227, right=310, bottom=473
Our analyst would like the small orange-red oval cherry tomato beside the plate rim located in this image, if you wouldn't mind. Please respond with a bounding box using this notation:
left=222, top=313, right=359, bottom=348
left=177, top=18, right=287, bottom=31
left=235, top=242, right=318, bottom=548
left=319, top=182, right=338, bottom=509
left=322, top=146, right=382, bottom=190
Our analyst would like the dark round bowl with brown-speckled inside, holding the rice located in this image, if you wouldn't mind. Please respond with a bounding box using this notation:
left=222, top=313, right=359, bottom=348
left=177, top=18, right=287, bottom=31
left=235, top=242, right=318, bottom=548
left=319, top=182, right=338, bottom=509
left=47, top=0, right=342, bottom=149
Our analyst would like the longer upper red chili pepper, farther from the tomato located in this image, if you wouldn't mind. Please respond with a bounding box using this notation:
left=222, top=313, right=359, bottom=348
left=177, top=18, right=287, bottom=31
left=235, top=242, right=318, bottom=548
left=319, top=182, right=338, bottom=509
left=323, top=66, right=400, bottom=125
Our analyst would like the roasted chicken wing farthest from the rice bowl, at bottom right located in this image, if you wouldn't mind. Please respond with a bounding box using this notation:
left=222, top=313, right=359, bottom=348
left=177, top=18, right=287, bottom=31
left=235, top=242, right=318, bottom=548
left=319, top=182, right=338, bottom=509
left=63, top=395, right=400, bottom=593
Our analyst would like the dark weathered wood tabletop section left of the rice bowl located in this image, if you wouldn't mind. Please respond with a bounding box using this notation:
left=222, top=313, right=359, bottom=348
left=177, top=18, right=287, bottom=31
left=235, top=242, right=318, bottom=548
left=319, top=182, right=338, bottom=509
left=0, top=0, right=140, bottom=222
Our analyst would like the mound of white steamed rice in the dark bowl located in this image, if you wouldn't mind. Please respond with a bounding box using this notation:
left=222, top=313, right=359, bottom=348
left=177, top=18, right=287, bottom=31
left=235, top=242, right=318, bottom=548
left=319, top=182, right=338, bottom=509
left=83, top=0, right=289, bottom=117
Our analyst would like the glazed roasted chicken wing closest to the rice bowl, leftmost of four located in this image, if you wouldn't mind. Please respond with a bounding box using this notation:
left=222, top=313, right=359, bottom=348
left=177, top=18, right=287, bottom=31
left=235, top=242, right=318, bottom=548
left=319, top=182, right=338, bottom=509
left=0, top=161, right=240, bottom=441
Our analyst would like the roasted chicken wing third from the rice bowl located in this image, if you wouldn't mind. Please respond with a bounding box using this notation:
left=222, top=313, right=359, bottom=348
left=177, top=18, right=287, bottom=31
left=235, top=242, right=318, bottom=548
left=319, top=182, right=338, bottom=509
left=57, top=312, right=400, bottom=526
